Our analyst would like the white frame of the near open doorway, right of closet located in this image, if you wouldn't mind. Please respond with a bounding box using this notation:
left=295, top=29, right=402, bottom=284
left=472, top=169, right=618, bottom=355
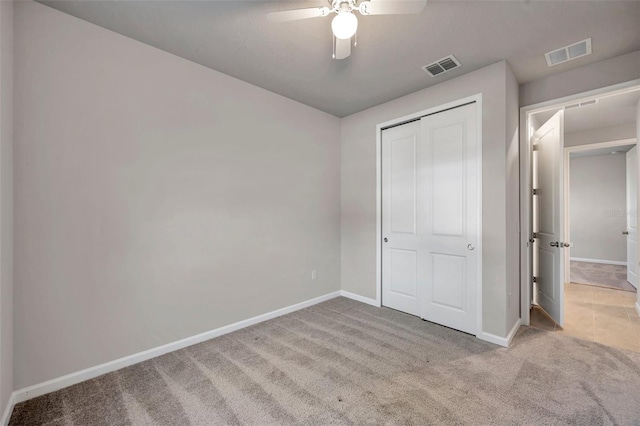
left=520, top=79, right=640, bottom=325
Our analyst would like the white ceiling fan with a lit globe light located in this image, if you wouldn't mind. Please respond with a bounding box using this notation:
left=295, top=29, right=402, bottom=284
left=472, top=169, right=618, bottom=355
left=267, top=0, right=427, bottom=59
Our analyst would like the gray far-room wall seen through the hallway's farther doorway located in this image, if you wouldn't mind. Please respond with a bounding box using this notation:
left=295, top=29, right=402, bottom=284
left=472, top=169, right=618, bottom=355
left=569, top=154, right=627, bottom=262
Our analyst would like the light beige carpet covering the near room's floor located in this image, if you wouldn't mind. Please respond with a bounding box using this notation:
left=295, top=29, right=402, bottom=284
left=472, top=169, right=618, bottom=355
left=10, top=298, right=640, bottom=425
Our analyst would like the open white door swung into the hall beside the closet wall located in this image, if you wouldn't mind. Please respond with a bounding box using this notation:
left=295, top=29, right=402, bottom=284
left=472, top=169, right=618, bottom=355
left=533, top=111, right=565, bottom=326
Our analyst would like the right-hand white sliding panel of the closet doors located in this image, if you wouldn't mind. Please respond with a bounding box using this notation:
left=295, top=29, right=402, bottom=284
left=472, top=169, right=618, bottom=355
left=420, top=104, right=479, bottom=334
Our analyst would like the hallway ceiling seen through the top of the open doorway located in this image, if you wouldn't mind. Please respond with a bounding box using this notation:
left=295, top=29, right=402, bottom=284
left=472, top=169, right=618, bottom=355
left=535, top=90, right=640, bottom=134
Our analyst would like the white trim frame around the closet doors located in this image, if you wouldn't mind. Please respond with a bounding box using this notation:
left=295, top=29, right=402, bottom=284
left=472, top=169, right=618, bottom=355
left=375, top=93, right=482, bottom=338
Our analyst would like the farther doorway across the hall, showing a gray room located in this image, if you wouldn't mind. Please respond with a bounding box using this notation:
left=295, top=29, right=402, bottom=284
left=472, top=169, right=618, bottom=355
left=565, top=141, right=640, bottom=293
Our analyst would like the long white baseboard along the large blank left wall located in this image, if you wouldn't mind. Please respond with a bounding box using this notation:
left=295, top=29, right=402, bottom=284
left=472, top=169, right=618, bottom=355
left=12, top=290, right=341, bottom=407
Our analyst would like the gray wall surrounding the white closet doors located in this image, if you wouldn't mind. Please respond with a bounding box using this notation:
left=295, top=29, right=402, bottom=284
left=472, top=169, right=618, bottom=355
left=341, top=62, right=518, bottom=336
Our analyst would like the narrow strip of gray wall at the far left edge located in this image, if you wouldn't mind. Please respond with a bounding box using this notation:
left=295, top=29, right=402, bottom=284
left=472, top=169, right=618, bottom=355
left=0, top=1, right=13, bottom=412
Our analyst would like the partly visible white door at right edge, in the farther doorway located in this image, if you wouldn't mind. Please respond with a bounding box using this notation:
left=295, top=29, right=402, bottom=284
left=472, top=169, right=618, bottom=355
left=627, top=147, right=638, bottom=288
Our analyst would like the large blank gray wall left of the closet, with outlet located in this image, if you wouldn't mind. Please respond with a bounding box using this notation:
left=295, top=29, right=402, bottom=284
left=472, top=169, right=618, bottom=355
left=14, top=2, right=340, bottom=388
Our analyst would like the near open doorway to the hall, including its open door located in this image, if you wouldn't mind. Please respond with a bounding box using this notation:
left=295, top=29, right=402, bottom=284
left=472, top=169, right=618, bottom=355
left=521, top=81, right=640, bottom=351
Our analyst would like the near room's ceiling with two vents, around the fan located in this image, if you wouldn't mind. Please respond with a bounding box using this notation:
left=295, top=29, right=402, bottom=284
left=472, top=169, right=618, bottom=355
left=40, top=0, right=640, bottom=117
